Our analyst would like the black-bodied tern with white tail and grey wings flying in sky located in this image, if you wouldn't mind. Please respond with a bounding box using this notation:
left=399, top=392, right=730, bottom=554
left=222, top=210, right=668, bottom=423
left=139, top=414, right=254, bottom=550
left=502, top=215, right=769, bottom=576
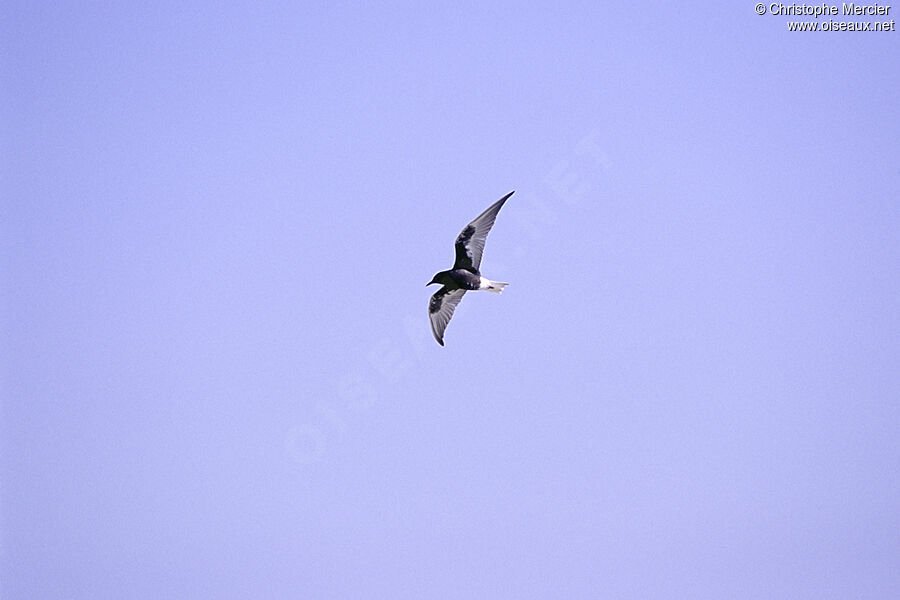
left=425, top=190, right=515, bottom=346
